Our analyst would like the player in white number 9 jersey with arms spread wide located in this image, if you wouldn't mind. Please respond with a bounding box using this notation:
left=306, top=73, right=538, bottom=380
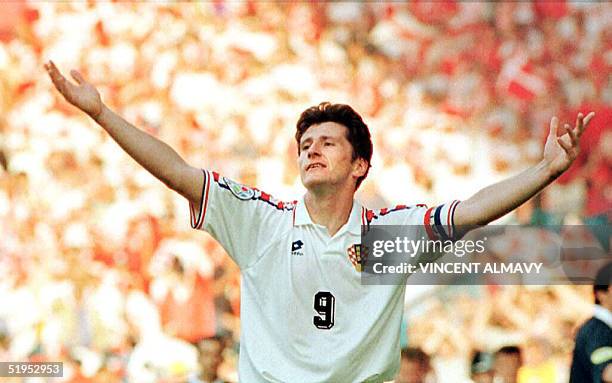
left=45, top=62, right=593, bottom=383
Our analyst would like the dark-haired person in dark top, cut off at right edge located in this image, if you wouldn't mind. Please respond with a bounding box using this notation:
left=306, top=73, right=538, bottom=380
left=570, top=263, right=612, bottom=383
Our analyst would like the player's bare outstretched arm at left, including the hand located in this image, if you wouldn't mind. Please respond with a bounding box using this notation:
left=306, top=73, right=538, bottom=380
left=45, top=61, right=203, bottom=206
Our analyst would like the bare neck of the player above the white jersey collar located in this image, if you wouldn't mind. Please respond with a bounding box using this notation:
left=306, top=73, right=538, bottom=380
left=304, top=186, right=354, bottom=236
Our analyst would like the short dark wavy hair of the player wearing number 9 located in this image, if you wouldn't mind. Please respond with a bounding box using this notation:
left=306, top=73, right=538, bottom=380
left=295, top=102, right=373, bottom=189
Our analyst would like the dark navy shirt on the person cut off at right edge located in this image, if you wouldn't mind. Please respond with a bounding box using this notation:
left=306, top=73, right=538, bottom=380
left=570, top=307, right=612, bottom=383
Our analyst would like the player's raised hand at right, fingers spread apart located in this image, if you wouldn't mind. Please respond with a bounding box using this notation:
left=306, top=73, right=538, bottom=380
left=543, top=112, right=595, bottom=177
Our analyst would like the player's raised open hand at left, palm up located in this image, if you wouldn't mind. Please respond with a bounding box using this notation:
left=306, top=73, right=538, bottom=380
left=45, top=61, right=103, bottom=118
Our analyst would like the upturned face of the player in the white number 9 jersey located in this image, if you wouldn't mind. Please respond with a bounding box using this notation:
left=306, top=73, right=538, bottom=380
left=298, top=122, right=367, bottom=190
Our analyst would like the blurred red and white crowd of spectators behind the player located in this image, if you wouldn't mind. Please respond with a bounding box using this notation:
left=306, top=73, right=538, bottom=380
left=0, top=0, right=612, bottom=383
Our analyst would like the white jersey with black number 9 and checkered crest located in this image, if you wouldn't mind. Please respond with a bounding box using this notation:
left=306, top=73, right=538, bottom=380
left=190, top=171, right=458, bottom=383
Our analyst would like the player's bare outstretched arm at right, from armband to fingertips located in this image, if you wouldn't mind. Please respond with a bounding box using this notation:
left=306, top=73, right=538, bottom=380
left=454, top=112, right=595, bottom=227
